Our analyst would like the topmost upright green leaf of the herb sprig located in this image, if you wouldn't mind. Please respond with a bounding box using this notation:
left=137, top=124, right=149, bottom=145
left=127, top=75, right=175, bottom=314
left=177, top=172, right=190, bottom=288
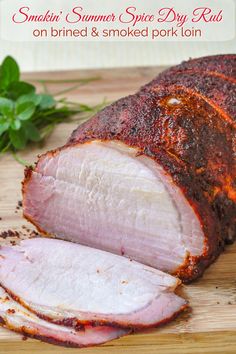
left=0, top=56, right=20, bottom=90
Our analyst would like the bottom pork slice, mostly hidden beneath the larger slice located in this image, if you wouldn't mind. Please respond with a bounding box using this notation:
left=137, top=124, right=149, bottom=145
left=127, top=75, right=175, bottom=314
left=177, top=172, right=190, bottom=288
left=0, top=287, right=129, bottom=347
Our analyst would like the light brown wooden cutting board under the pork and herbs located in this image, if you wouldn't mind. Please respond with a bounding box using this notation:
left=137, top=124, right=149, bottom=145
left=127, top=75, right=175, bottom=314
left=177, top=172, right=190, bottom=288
left=0, top=67, right=236, bottom=354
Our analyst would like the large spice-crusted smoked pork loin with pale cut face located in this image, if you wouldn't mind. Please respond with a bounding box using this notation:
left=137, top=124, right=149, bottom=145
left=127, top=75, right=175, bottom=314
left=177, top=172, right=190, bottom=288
left=23, top=55, right=236, bottom=282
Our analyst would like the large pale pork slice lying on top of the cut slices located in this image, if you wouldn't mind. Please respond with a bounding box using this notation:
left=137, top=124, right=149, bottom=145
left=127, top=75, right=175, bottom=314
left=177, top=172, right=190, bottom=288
left=0, top=238, right=186, bottom=330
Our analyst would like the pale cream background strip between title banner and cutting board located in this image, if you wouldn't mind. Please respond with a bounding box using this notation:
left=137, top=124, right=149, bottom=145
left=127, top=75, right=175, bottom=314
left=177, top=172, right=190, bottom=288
left=0, top=0, right=236, bottom=72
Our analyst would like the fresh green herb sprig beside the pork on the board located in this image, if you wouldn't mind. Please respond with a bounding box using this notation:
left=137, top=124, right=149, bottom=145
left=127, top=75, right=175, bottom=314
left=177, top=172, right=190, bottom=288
left=0, top=56, right=99, bottom=162
